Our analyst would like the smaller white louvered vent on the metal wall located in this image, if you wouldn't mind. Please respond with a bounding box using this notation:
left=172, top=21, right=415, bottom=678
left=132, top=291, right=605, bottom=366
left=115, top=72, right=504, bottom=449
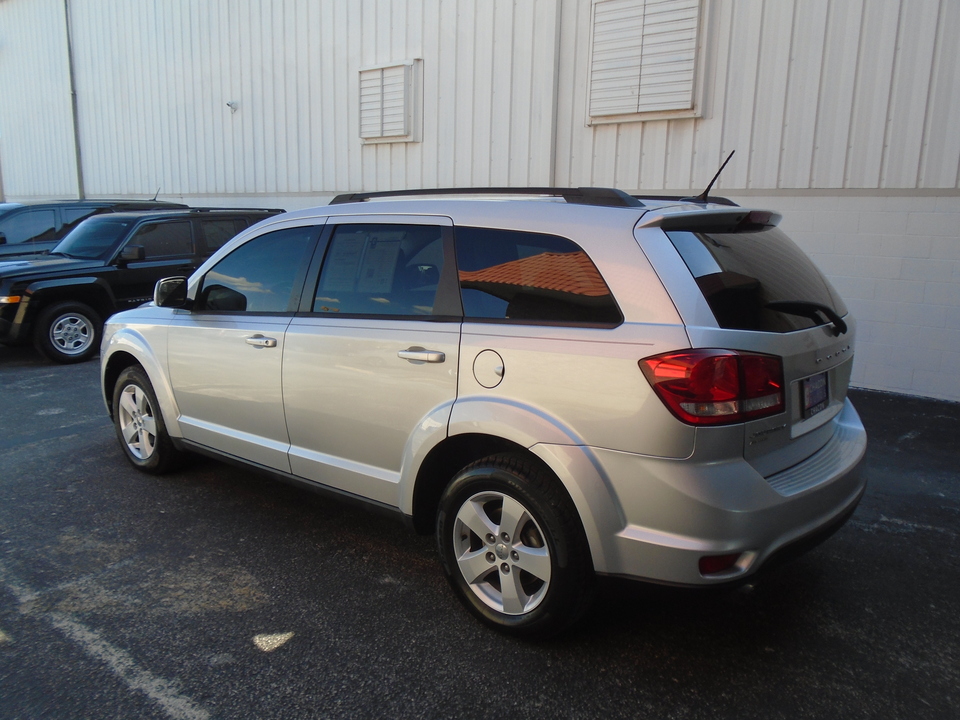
left=360, top=63, right=417, bottom=142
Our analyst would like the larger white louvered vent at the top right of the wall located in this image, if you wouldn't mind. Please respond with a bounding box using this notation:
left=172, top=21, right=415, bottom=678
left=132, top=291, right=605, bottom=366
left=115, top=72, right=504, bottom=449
left=589, top=0, right=700, bottom=119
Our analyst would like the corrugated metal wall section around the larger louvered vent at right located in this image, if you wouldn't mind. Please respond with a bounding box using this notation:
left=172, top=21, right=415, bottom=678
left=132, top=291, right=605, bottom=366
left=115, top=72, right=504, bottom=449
left=556, top=0, right=960, bottom=191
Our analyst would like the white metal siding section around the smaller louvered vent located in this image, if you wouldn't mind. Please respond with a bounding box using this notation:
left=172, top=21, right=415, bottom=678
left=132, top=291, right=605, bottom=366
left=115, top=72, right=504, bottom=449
left=71, top=0, right=559, bottom=196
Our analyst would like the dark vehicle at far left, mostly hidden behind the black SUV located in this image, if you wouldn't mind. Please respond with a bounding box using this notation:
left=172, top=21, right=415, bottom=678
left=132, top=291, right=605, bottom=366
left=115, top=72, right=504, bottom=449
left=0, top=200, right=187, bottom=259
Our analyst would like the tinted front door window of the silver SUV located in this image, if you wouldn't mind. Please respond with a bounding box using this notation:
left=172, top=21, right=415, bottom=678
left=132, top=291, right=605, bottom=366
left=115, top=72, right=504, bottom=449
left=197, top=227, right=318, bottom=312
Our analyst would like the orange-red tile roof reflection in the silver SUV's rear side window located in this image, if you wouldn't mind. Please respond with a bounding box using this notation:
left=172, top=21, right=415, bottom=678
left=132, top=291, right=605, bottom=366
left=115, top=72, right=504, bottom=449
left=460, top=250, right=610, bottom=297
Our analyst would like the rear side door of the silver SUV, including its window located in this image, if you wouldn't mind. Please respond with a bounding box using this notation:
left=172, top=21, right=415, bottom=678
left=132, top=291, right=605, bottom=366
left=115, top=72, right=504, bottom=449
left=283, top=216, right=461, bottom=506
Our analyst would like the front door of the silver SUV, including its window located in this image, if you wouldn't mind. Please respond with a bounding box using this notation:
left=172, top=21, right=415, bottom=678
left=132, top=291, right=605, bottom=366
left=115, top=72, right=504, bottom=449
left=167, top=226, right=320, bottom=472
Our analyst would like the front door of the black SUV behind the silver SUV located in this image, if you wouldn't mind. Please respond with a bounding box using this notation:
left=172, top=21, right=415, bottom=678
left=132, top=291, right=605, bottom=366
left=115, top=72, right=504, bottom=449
left=111, top=218, right=200, bottom=310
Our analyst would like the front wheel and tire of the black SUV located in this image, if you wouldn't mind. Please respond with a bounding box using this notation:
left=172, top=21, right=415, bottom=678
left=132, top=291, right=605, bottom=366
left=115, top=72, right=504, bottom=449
left=33, top=302, right=103, bottom=364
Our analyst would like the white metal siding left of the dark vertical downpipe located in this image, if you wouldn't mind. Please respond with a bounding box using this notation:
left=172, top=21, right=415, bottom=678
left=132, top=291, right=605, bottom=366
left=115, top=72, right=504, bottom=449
left=0, top=0, right=77, bottom=198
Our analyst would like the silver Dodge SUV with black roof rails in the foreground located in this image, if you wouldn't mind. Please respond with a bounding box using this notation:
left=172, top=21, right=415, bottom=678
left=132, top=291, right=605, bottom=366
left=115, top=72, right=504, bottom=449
left=101, top=188, right=866, bottom=637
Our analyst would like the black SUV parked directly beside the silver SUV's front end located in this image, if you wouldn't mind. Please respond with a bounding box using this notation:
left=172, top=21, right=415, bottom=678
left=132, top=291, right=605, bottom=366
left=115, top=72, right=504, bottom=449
left=0, top=208, right=283, bottom=363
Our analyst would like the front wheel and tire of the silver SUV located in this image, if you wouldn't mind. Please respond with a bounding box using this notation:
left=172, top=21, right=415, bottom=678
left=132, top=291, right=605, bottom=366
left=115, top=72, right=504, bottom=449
left=113, top=366, right=184, bottom=475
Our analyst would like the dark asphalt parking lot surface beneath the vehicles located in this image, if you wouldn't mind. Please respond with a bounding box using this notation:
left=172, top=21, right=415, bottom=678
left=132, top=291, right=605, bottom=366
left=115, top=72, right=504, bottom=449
left=0, top=348, right=960, bottom=720
